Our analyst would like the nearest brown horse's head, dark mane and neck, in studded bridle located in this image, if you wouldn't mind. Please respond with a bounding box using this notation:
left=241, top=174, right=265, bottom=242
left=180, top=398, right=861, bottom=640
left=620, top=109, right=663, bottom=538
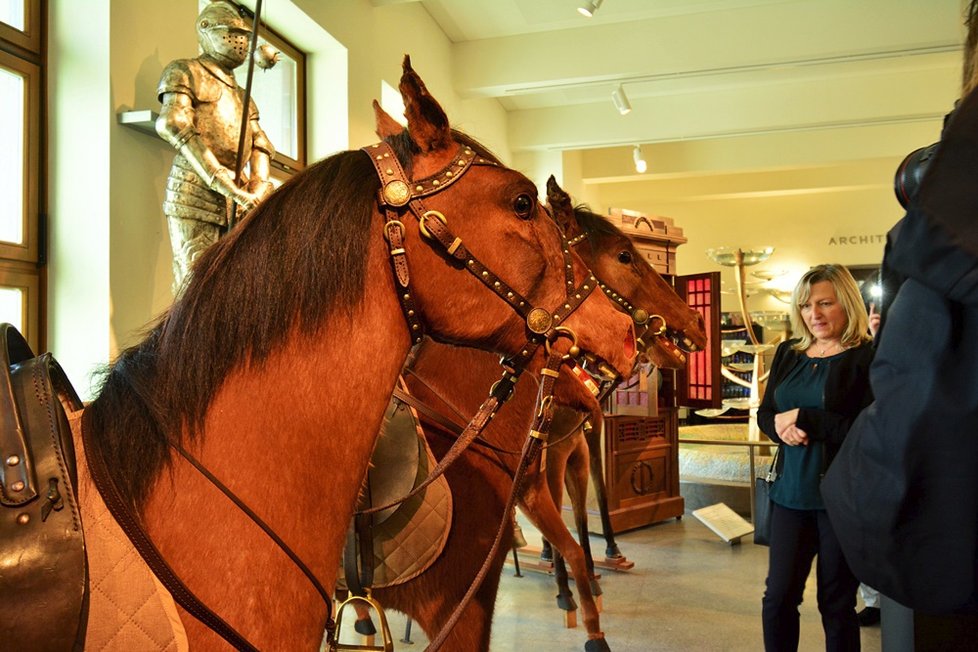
left=55, top=58, right=634, bottom=650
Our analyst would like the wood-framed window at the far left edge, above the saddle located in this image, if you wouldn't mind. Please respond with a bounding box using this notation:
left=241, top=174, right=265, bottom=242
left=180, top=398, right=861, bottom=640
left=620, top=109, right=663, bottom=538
left=0, top=0, right=43, bottom=351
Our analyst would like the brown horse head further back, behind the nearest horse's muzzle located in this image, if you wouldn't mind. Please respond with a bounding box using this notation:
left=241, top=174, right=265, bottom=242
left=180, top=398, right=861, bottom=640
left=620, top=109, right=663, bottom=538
left=547, top=176, right=707, bottom=369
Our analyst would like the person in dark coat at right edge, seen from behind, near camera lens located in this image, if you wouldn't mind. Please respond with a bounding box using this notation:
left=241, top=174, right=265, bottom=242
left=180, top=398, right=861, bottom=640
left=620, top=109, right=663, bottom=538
left=822, top=0, right=978, bottom=620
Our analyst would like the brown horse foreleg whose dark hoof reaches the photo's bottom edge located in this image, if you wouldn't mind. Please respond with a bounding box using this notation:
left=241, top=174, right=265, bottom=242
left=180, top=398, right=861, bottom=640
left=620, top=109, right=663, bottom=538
left=523, top=472, right=610, bottom=652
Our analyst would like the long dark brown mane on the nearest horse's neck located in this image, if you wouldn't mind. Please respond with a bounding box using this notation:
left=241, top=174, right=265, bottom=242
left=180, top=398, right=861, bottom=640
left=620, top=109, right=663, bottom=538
left=85, top=132, right=496, bottom=507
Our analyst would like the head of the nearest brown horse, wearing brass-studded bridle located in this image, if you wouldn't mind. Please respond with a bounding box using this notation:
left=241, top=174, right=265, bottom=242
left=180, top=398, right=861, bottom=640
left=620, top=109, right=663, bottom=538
left=374, top=57, right=636, bottom=400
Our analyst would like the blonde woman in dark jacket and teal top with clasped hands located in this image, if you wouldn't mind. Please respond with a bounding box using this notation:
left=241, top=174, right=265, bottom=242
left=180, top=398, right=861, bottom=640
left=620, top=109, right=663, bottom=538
left=757, top=265, right=873, bottom=652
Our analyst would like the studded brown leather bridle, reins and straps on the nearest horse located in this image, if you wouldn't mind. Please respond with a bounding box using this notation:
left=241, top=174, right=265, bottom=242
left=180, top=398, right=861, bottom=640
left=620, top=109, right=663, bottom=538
left=83, top=142, right=597, bottom=652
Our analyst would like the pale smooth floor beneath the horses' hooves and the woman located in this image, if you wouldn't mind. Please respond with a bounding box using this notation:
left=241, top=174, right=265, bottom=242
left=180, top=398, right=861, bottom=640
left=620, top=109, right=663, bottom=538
left=346, top=514, right=880, bottom=652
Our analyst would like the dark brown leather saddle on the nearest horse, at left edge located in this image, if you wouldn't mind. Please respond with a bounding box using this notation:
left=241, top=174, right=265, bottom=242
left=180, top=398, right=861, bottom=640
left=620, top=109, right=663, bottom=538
left=0, top=324, right=88, bottom=650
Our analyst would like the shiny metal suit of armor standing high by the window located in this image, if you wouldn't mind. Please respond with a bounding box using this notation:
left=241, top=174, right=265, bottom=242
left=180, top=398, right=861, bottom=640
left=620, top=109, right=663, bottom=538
left=156, top=1, right=275, bottom=293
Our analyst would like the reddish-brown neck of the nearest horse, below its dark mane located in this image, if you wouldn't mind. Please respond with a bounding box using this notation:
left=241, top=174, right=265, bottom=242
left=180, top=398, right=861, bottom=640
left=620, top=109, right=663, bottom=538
left=144, top=238, right=409, bottom=649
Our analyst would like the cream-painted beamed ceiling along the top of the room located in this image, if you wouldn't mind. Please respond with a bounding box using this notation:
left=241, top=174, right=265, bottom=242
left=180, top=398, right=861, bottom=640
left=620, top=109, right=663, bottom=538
left=386, top=0, right=963, bottom=151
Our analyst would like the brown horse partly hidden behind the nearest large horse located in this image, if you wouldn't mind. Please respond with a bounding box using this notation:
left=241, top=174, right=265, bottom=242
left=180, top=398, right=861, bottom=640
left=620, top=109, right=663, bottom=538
left=350, top=169, right=706, bottom=651
